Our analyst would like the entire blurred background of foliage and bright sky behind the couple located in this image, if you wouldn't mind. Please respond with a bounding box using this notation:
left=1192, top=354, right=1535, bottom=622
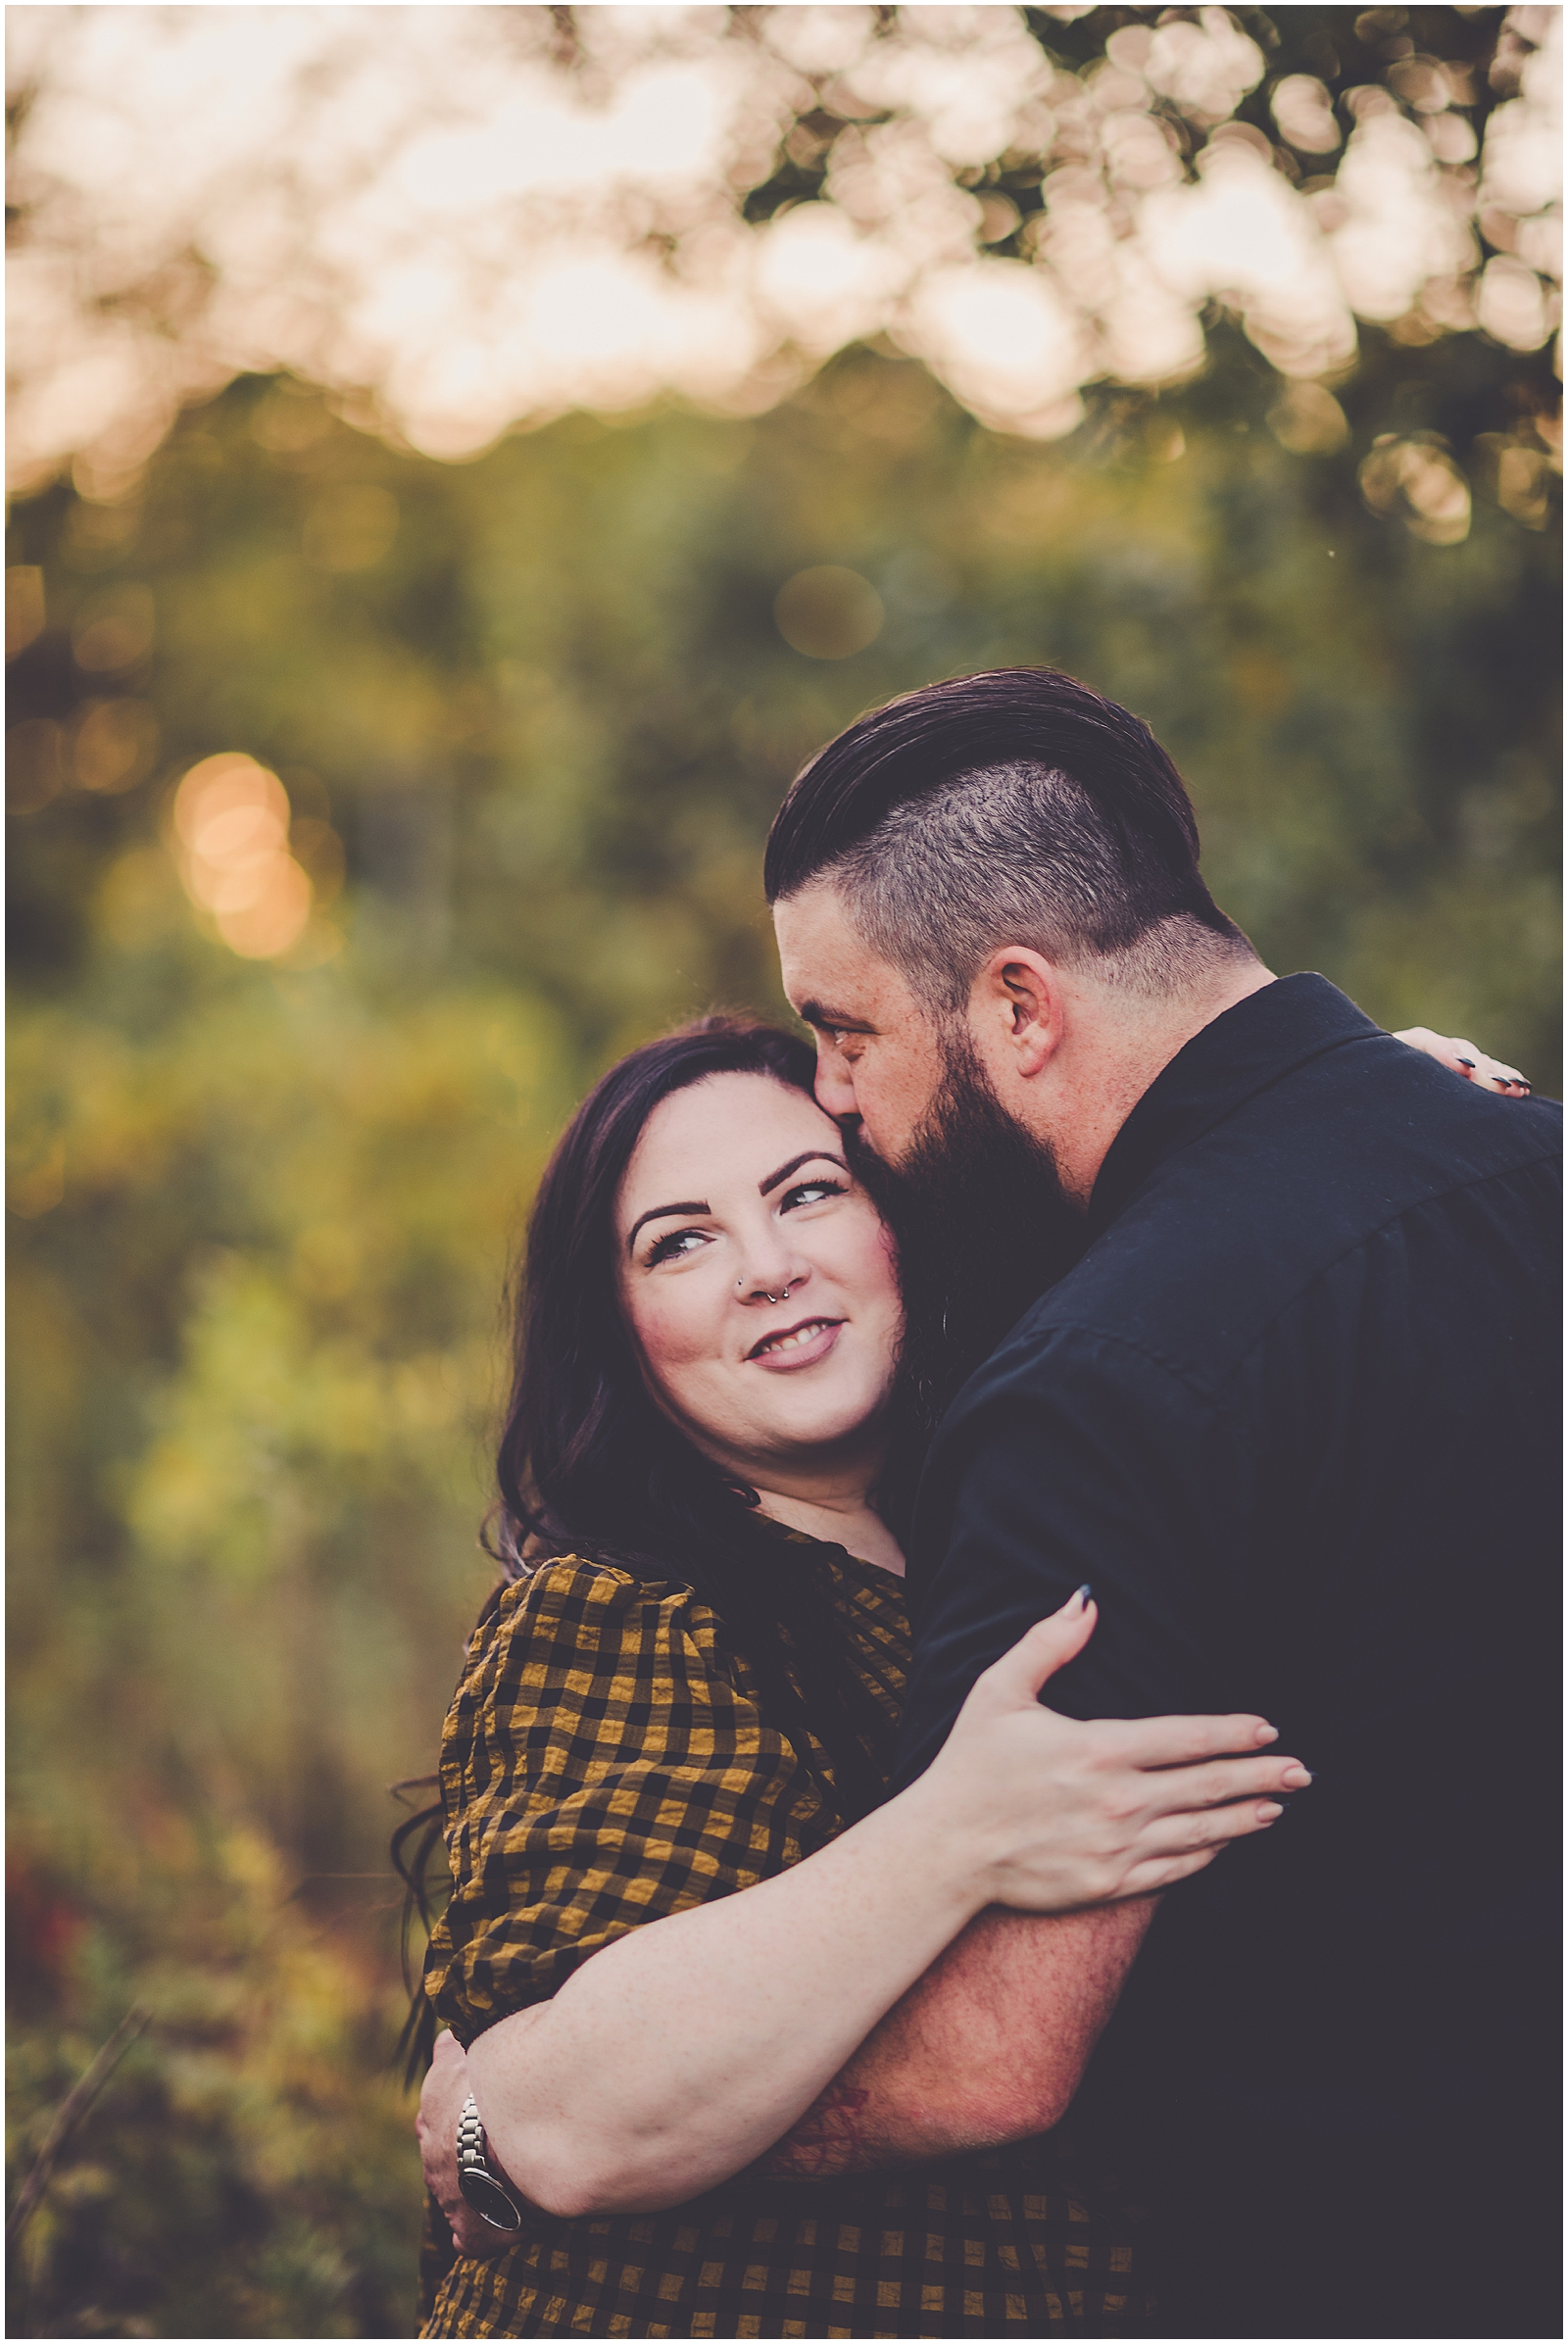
left=7, top=5, right=1561, bottom=2337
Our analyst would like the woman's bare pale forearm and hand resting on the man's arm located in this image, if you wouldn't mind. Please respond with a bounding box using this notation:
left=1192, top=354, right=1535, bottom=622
left=429, top=1598, right=1308, bottom=2218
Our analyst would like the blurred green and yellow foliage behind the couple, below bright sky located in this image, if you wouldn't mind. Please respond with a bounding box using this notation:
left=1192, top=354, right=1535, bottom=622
left=7, top=316, right=1558, bottom=2334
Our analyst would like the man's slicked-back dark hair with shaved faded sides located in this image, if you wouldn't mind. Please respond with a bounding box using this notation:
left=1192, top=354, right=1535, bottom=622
left=764, top=668, right=1251, bottom=1017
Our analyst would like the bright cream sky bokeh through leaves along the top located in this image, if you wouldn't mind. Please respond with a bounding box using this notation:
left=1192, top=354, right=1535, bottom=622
left=12, top=7, right=1561, bottom=492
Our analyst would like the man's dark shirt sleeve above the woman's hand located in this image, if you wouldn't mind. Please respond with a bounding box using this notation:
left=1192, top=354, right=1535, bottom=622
left=896, top=1329, right=1265, bottom=1786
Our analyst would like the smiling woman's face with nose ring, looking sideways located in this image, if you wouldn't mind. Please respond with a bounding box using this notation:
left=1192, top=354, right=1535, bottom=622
left=616, top=1074, right=903, bottom=1482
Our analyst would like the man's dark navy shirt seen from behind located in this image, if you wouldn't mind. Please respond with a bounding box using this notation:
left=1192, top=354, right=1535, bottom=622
left=903, top=975, right=1561, bottom=2337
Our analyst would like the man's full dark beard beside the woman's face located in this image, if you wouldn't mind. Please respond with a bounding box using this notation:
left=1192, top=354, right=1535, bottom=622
left=846, top=1031, right=1085, bottom=1482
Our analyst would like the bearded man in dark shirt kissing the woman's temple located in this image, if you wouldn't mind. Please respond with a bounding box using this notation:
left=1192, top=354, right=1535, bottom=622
left=766, top=670, right=1561, bottom=2337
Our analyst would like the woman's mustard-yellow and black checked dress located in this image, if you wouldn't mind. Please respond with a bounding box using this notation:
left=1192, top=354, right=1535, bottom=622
left=419, top=1547, right=1147, bottom=2337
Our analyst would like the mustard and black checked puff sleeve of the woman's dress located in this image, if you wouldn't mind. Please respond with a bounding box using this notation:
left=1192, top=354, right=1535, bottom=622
left=424, top=1561, right=834, bottom=2044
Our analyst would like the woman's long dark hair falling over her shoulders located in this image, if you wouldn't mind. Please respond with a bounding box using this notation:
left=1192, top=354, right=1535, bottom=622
left=394, top=1017, right=886, bottom=2068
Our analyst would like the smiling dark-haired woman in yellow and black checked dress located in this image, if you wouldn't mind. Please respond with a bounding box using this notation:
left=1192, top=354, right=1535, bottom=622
left=408, top=1020, right=1305, bottom=2337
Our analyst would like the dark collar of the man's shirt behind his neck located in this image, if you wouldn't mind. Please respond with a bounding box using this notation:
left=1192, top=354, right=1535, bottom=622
left=1088, top=975, right=1381, bottom=1238
